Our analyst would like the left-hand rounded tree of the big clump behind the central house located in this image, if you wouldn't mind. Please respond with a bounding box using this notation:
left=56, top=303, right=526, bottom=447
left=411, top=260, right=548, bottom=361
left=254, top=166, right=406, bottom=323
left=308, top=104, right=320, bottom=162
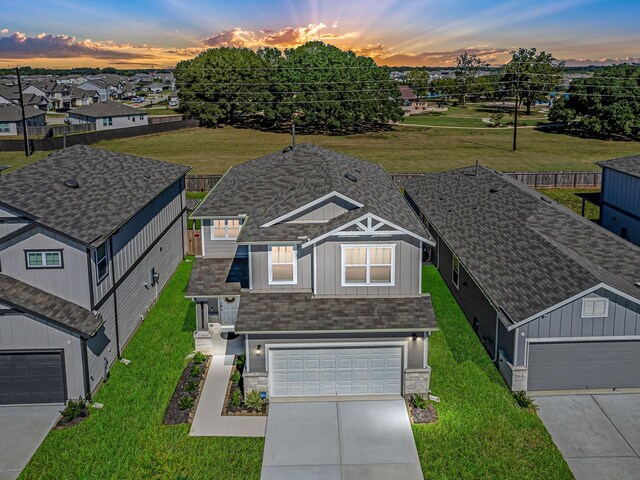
left=174, top=47, right=271, bottom=126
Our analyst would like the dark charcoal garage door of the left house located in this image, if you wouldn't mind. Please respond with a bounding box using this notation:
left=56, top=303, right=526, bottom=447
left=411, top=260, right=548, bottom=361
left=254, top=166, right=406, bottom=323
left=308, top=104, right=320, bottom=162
left=0, top=352, right=66, bottom=405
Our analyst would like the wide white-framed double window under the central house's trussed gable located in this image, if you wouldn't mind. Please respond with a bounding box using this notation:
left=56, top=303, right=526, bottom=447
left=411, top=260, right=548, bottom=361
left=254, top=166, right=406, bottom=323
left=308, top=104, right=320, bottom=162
left=342, top=245, right=395, bottom=287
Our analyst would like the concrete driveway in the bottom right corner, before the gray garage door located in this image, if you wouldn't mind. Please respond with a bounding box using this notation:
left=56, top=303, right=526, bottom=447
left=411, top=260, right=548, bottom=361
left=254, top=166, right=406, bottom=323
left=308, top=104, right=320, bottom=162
left=535, top=394, right=640, bottom=480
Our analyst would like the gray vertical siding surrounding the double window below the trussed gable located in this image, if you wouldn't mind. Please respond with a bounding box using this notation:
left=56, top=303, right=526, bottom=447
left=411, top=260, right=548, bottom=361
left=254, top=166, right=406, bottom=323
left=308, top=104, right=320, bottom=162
left=316, top=235, right=422, bottom=296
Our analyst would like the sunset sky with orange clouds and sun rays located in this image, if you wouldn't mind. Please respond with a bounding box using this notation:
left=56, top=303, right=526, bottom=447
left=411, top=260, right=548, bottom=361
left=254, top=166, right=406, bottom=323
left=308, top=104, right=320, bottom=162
left=0, top=0, right=640, bottom=68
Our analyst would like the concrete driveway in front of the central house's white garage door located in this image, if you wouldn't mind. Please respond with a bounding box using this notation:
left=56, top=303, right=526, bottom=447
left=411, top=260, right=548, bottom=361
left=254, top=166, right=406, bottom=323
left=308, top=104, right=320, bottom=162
left=262, top=399, right=423, bottom=480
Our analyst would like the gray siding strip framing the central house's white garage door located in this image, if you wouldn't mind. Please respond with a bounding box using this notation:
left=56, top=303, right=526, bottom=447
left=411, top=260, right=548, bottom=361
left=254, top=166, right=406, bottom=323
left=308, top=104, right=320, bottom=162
left=248, top=332, right=428, bottom=372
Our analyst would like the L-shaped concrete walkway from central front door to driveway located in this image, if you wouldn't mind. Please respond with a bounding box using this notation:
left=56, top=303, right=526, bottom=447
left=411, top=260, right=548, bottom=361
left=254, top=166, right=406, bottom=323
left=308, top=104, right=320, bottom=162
left=189, top=339, right=267, bottom=437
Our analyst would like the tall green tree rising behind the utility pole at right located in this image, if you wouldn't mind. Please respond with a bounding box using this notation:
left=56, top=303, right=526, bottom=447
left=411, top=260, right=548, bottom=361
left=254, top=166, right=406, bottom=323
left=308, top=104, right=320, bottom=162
left=504, top=48, right=564, bottom=115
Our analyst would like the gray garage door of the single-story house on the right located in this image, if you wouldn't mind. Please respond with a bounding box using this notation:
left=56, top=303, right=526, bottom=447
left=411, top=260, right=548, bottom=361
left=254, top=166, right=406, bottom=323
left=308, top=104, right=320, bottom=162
left=528, top=341, right=640, bottom=391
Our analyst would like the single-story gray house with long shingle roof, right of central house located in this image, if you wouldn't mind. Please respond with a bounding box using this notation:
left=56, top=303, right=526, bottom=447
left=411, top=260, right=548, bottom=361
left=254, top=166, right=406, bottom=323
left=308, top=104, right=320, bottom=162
left=402, top=167, right=640, bottom=391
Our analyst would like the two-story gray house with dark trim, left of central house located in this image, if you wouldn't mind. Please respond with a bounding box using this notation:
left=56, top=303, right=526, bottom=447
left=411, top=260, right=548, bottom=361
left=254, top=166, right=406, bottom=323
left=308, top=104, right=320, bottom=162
left=0, top=146, right=189, bottom=404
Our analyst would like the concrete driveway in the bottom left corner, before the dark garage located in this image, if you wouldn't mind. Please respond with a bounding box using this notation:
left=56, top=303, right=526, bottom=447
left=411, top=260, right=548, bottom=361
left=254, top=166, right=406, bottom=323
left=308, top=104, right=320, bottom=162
left=0, top=405, right=64, bottom=480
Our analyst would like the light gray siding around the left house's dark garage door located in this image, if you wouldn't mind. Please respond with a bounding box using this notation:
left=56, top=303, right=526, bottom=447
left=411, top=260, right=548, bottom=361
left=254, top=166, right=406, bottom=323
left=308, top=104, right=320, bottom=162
left=0, top=304, right=85, bottom=398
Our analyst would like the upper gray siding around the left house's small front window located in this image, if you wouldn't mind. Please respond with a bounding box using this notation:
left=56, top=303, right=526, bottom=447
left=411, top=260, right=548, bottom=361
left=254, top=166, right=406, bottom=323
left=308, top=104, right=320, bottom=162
left=0, top=227, right=91, bottom=309
